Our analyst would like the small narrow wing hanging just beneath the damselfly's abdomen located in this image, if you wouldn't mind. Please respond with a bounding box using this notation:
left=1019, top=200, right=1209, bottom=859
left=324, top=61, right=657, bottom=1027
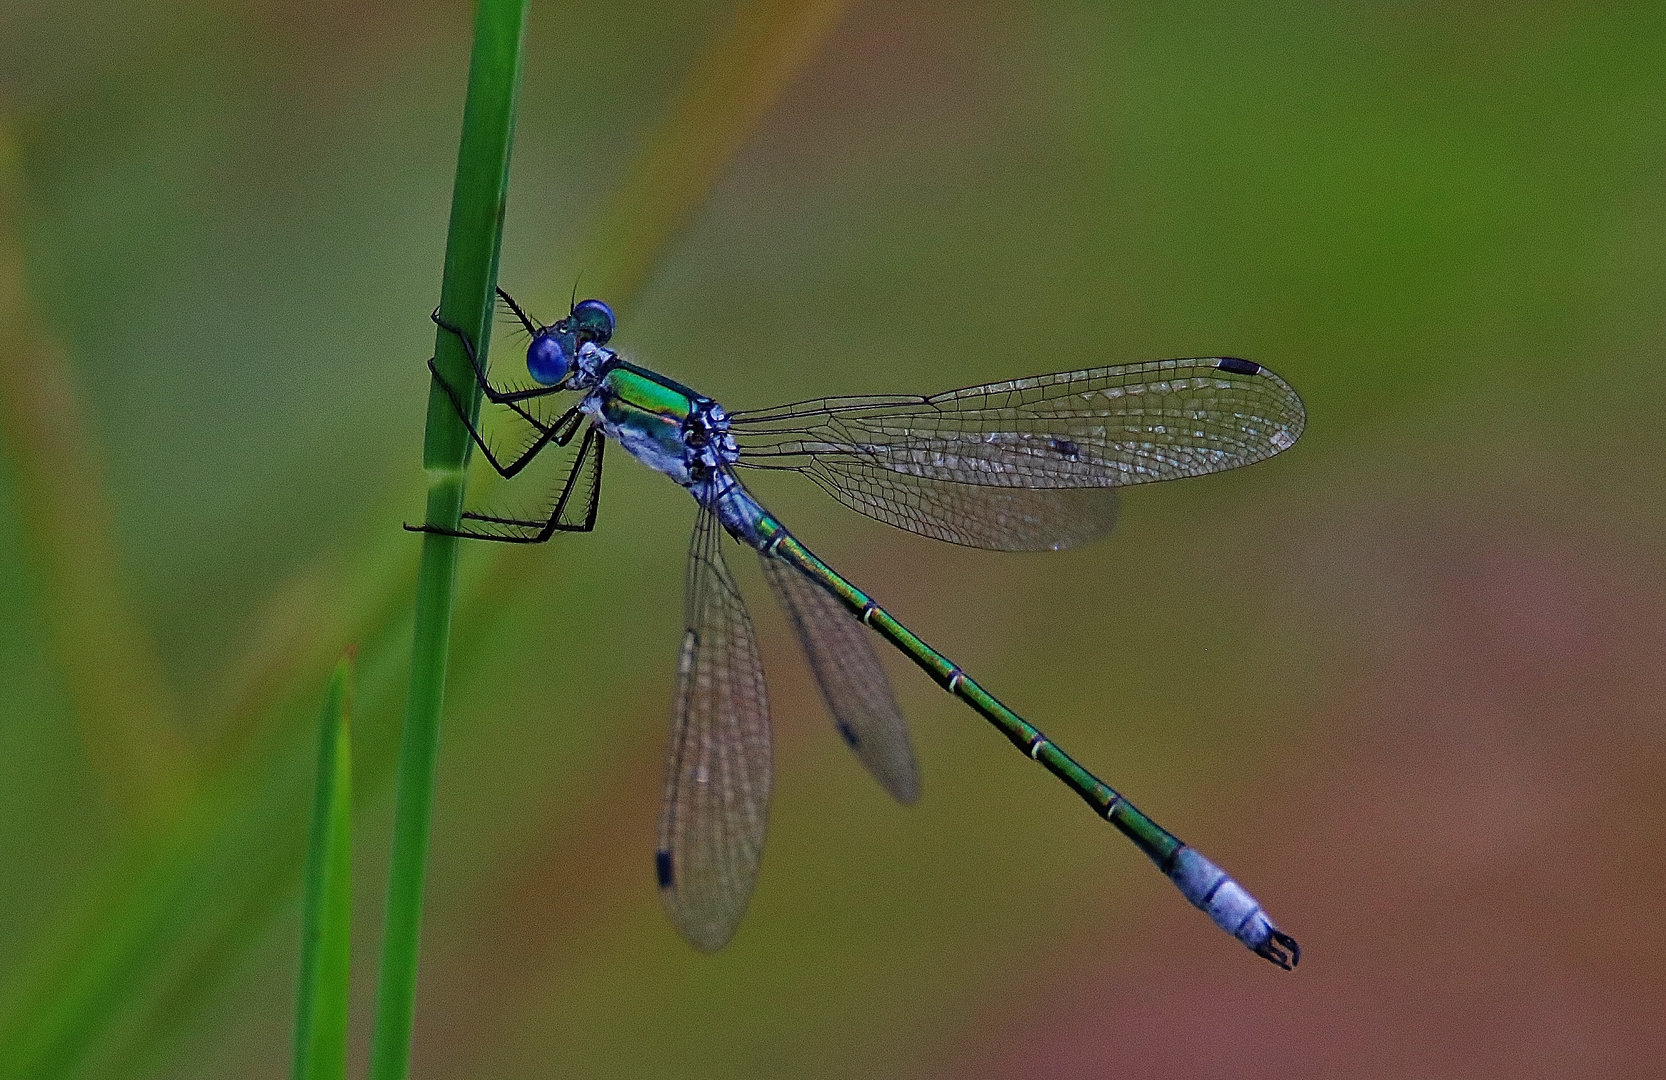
left=763, top=555, right=920, bottom=803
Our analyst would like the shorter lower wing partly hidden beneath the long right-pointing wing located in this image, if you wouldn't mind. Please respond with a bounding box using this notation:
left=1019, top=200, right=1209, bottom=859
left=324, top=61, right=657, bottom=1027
left=798, top=458, right=1121, bottom=552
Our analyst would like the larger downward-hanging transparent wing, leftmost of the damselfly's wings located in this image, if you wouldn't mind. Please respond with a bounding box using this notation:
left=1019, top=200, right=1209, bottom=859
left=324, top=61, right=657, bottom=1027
left=655, top=510, right=770, bottom=952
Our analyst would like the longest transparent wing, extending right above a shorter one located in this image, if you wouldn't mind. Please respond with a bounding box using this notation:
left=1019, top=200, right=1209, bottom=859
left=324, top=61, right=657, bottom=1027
left=733, top=357, right=1306, bottom=488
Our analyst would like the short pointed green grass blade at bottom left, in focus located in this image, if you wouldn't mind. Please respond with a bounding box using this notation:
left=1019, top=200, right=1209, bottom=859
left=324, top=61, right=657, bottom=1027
left=292, top=657, right=353, bottom=1080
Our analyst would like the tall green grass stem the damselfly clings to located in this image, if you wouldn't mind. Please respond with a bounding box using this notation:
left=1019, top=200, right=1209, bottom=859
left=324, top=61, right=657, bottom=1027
left=370, top=0, right=526, bottom=1080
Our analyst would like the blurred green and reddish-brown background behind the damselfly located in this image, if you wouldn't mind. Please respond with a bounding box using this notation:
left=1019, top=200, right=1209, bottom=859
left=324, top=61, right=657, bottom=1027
left=0, top=0, right=1666, bottom=1080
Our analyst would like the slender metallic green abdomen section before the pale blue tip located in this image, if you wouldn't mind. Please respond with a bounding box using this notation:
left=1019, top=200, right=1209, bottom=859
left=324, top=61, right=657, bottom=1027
left=760, top=530, right=1185, bottom=873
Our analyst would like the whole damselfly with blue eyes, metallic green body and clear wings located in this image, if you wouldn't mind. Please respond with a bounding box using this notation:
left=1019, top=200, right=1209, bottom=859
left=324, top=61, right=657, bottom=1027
left=407, top=288, right=1306, bottom=970
